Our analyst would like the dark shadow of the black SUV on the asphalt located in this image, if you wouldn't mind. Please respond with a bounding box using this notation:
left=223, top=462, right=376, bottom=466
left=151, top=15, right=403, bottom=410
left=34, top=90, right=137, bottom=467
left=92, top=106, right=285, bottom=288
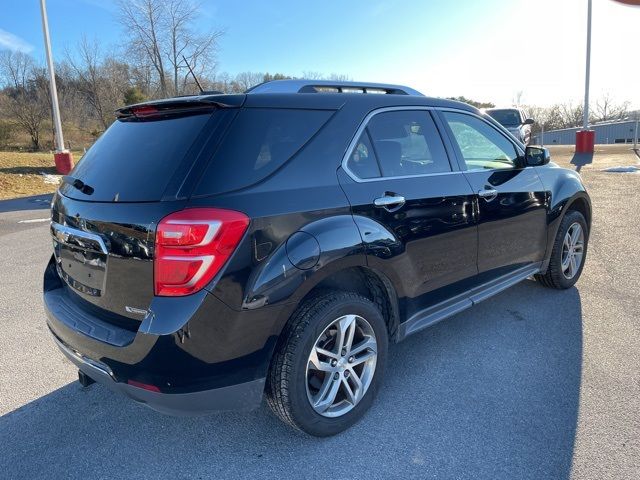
left=0, top=281, right=582, bottom=479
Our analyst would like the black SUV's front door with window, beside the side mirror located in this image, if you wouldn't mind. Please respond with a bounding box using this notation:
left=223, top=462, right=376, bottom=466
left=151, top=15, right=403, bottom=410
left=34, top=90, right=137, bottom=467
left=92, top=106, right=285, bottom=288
left=440, top=110, right=547, bottom=275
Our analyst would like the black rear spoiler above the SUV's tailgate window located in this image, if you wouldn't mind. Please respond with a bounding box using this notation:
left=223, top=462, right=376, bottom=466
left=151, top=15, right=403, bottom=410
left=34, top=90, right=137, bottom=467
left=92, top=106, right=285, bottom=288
left=115, top=95, right=246, bottom=118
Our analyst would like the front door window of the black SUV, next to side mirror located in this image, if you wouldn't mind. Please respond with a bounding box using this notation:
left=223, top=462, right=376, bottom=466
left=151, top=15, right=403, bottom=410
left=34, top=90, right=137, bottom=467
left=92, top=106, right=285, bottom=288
left=442, top=112, right=518, bottom=170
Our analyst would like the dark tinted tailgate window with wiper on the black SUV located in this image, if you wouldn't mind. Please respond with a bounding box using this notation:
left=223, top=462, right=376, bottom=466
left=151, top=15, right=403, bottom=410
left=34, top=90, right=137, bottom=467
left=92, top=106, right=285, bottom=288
left=61, top=113, right=215, bottom=202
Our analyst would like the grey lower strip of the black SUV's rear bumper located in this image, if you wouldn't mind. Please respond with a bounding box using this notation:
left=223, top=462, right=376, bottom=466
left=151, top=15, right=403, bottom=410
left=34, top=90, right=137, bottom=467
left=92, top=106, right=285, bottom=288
left=53, top=335, right=265, bottom=416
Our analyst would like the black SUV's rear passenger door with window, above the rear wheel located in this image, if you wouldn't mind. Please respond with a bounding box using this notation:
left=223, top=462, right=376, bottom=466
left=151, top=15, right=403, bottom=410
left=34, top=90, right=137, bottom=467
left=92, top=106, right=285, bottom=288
left=339, top=107, right=477, bottom=317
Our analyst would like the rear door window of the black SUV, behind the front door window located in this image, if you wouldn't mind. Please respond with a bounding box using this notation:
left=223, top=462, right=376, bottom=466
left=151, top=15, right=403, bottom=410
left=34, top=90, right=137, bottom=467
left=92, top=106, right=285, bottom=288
left=347, top=110, right=451, bottom=179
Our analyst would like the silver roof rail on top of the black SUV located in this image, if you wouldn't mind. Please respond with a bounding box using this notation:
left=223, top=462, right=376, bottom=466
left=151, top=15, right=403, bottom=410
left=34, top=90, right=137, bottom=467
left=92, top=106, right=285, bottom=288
left=245, top=80, right=424, bottom=97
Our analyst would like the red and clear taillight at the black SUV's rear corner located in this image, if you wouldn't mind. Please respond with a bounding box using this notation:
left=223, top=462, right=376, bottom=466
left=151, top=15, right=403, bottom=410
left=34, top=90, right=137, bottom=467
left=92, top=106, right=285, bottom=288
left=153, top=208, right=249, bottom=296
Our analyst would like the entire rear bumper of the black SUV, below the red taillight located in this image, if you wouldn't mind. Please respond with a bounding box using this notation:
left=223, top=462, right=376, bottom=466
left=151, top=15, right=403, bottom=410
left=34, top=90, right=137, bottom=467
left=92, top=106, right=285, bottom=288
left=43, top=256, right=280, bottom=415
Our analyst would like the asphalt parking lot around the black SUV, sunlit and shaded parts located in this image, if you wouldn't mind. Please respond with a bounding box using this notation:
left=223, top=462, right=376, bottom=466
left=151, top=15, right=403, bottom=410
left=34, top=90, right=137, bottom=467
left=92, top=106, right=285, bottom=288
left=0, top=147, right=640, bottom=479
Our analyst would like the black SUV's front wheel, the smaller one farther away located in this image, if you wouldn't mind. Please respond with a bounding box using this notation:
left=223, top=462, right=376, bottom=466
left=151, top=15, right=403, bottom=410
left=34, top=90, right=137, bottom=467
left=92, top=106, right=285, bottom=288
left=535, top=210, right=589, bottom=290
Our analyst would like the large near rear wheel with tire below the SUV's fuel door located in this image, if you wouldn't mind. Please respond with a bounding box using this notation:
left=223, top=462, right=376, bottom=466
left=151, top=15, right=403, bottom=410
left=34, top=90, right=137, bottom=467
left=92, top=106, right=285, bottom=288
left=266, top=291, right=388, bottom=437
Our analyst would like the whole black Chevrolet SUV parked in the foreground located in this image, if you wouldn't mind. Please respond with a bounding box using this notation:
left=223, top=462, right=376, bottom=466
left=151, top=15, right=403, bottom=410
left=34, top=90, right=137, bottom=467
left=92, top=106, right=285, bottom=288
left=44, top=80, right=591, bottom=436
